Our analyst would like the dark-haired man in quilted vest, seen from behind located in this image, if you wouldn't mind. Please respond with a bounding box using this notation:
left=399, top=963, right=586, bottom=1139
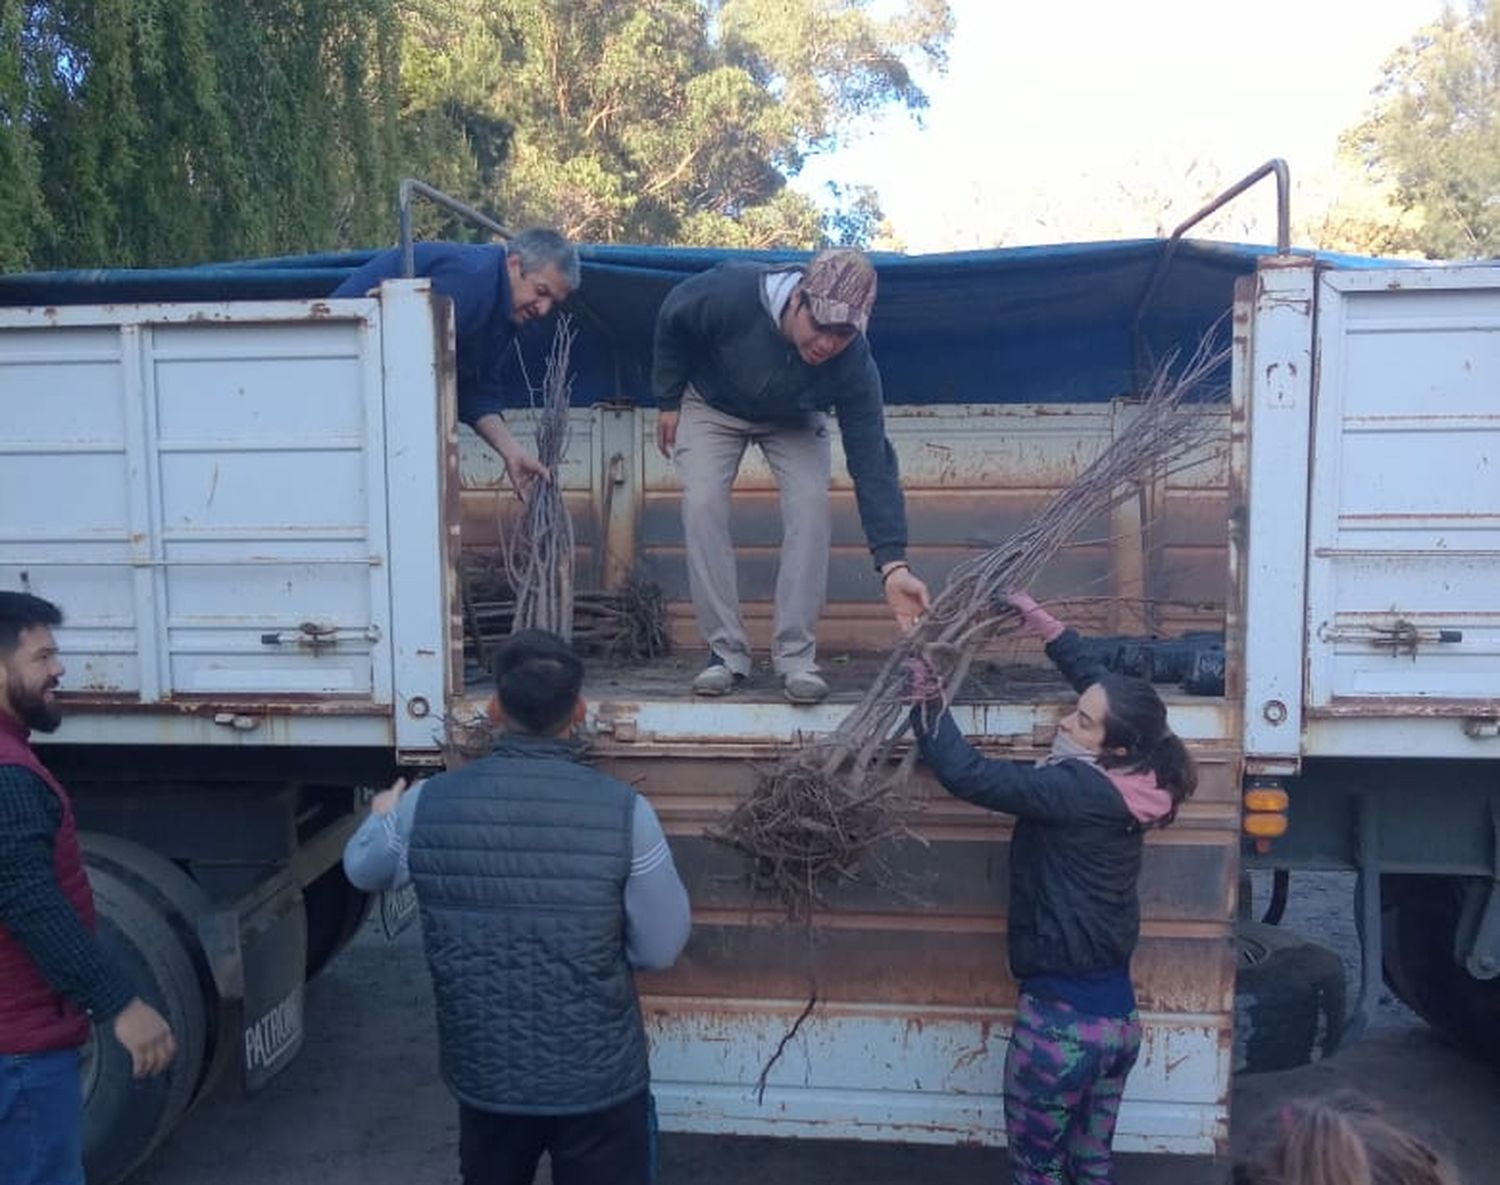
left=344, top=630, right=692, bottom=1185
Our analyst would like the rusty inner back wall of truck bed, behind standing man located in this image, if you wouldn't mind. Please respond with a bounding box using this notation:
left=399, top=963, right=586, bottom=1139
left=461, top=404, right=1229, bottom=657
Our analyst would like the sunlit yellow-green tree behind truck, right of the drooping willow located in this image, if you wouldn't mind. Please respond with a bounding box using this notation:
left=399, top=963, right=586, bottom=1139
left=402, top=0, right=953, bottom=248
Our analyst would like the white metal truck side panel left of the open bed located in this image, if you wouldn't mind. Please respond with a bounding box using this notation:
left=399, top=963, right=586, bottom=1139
left=0, top=295, right=452, bottom=750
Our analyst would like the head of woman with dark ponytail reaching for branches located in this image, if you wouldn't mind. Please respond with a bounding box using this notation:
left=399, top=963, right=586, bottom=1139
left=1058, top=672, right=1199, bottom=822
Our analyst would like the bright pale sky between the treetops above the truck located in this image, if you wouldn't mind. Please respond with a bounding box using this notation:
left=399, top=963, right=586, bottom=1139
left=795, top=0, right=1443, bottom=251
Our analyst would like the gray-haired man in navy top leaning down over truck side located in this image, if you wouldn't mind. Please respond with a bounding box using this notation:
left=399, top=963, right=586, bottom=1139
left=333, top=228, right=582, bottom=494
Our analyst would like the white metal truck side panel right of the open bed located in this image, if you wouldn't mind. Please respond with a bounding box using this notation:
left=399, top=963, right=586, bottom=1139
left=1307, top=269, right=1500, bottom=729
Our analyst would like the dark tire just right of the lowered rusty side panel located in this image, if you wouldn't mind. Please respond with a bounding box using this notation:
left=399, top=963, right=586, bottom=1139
left=1235, top=921, right=1346, bottom=1074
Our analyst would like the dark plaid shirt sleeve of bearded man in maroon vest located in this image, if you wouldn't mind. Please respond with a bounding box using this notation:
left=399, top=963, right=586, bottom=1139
left=0, top=765, right=137, bottom=1020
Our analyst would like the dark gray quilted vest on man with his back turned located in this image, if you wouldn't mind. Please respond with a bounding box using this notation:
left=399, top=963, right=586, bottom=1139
left=408, top=735, right=650, bottom=1115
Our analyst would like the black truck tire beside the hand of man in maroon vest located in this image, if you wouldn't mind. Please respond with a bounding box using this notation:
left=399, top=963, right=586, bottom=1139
left=83, top=867, right=209, bottom=1185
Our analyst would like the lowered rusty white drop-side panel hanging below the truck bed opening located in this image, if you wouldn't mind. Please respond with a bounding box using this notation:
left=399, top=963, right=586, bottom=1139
left=582, top=738, right=1239, bottom=1154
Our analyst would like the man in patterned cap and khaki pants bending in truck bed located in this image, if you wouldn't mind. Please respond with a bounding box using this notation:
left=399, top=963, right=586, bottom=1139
left=653, top=249, right=929, bottom=704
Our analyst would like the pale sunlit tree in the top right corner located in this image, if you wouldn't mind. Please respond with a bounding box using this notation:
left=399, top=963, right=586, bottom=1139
left=1346, top=0, right=1500, bottom=258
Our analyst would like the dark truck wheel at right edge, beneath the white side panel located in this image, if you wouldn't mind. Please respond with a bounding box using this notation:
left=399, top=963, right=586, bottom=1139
left=1380, top=876, right=1500, bottom=1062
